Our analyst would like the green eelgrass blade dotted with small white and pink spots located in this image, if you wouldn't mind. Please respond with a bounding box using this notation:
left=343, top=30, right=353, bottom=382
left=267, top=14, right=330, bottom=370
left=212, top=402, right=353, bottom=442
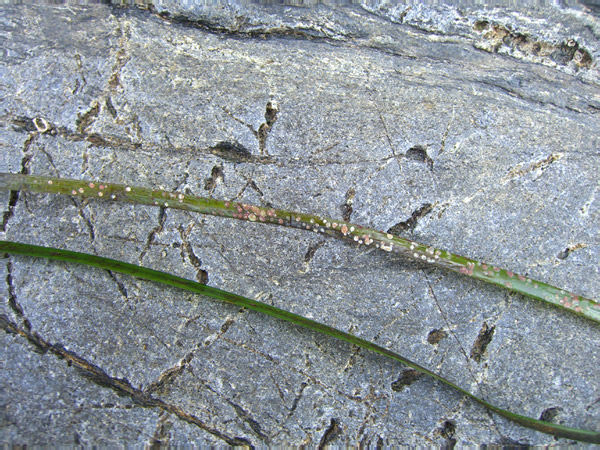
left=0, top=173, right=600, bottom=322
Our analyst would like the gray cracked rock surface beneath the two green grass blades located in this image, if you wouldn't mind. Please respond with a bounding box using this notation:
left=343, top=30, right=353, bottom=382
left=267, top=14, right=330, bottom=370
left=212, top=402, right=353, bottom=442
left=0, top=5, right=600, bottom=446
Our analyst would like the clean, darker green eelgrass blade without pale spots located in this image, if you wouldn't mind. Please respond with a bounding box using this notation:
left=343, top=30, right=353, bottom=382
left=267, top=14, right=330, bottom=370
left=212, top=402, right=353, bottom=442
left=0, top=241, right=600, bottom=444
